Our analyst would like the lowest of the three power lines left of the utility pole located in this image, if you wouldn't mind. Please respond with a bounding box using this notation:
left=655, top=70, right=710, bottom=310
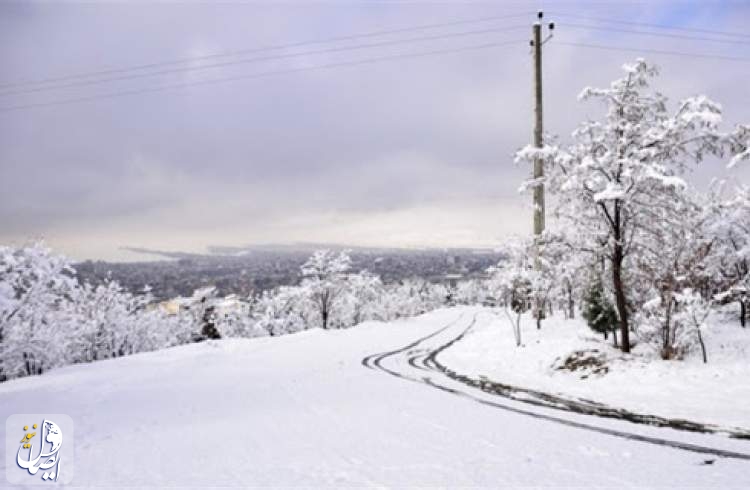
left=0, top=39, right=528, bottom=112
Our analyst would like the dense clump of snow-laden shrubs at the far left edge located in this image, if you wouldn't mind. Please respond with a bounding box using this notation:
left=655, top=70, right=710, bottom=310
left=0, top=243, right=195, bottom=380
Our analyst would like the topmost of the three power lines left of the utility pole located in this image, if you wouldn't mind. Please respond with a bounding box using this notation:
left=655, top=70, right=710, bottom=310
left=0, top=12, right=529, bottom=89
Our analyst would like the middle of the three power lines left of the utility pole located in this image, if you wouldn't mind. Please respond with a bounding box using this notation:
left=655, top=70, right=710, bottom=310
left=0, top=26, right=526, bottom=97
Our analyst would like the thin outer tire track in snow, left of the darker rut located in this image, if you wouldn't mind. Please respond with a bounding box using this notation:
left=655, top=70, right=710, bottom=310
left=368, top=313, right=750, bottom=461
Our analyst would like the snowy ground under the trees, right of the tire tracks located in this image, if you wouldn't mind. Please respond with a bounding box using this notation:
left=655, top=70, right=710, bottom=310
left=440, top=310, right=750, bottom=429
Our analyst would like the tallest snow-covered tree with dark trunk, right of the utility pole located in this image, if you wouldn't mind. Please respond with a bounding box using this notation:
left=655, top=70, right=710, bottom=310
left=518, top=59, right=750, bottom=352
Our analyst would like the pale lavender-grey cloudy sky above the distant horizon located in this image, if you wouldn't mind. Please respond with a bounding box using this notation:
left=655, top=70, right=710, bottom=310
left=0, top=0, right=750, bottom=260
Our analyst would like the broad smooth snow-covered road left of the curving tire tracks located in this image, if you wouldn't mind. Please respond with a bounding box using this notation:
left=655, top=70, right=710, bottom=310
left=0, top=308, right=750, bottom=488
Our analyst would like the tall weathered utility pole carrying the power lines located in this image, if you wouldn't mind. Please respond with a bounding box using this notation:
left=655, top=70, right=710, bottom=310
left=531, top=10, right=555, bottom=328
